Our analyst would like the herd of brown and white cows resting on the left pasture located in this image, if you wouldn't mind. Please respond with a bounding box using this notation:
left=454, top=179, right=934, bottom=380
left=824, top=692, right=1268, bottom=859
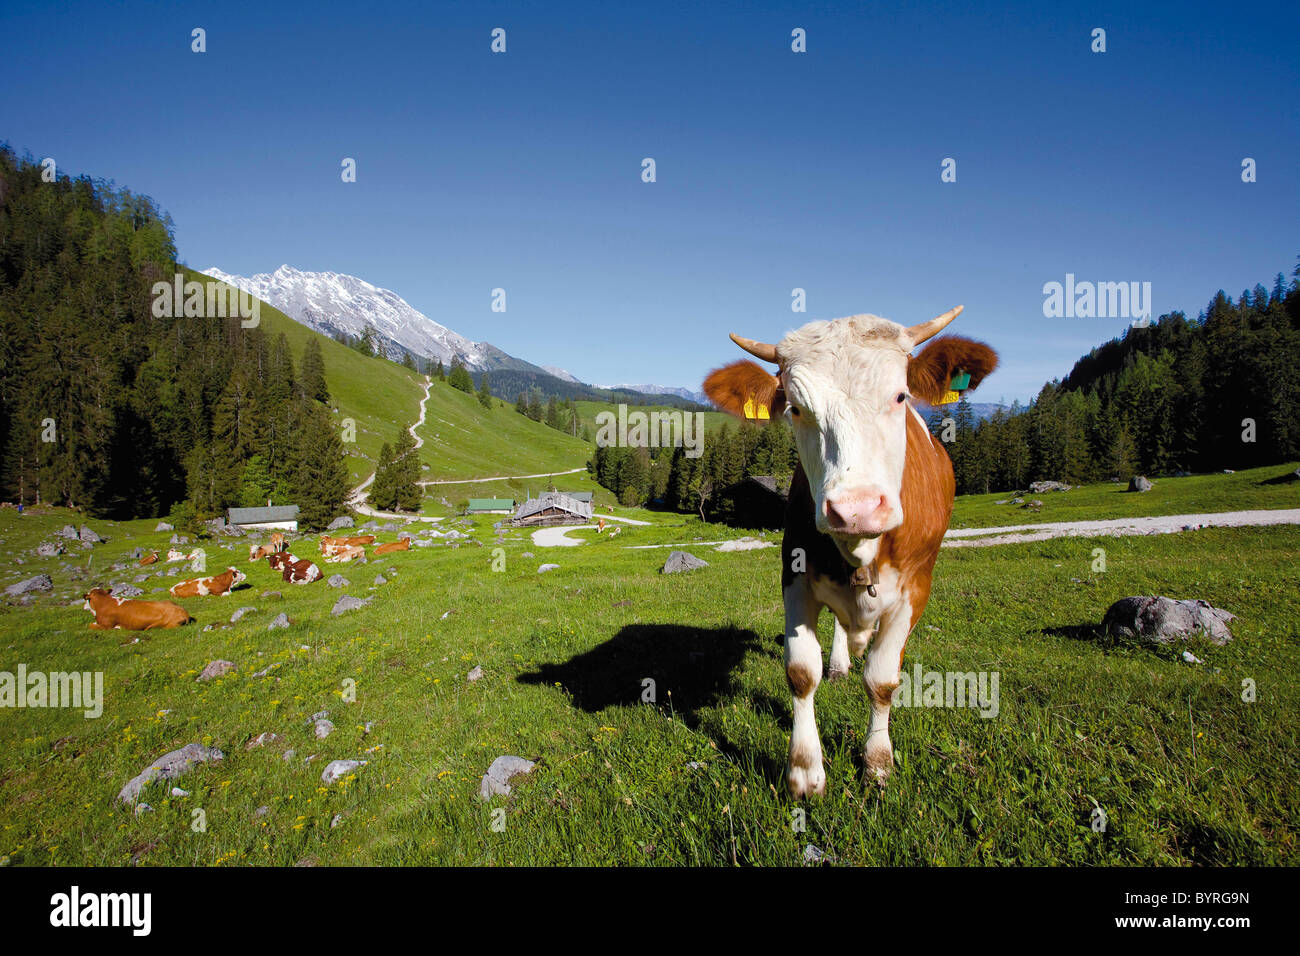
left=82, top=532, right=411, bottom=631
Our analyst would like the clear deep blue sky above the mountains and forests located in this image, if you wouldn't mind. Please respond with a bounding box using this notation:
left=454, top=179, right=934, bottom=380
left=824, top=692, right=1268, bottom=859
left=0, top=0, right=1300, bottom=401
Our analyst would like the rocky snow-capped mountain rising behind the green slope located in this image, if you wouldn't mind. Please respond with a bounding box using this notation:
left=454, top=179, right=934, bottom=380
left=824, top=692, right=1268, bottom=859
left=203, top=265, right=504, bottom=372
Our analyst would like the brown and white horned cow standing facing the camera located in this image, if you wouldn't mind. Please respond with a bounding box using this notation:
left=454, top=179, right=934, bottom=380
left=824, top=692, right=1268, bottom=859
left=705, top=306, right=997, bottom=797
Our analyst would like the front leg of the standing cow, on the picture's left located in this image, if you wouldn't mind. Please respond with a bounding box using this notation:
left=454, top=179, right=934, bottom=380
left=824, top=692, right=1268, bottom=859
left=784, top=580, right=826, bottom=799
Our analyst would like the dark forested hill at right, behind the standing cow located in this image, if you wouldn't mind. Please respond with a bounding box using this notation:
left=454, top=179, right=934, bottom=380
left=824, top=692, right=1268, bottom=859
left=930, top=268, right=1300, bottom=493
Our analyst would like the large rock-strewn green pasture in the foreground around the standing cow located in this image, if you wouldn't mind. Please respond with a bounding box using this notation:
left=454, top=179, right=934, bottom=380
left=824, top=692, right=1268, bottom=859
left=0, top=481, right=1300, bottom=865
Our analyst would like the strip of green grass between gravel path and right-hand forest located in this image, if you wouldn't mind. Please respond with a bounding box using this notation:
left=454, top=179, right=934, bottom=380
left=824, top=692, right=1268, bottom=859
left=952, top=462, right=1300, bottom=528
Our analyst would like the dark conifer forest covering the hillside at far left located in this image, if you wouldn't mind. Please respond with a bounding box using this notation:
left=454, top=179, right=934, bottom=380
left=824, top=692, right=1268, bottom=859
left=0, top=147, right=369, bottom=525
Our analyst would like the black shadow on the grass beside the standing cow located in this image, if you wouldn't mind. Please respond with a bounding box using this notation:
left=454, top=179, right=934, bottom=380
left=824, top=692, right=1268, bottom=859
left=519, top=624, right=761, bottom=728
